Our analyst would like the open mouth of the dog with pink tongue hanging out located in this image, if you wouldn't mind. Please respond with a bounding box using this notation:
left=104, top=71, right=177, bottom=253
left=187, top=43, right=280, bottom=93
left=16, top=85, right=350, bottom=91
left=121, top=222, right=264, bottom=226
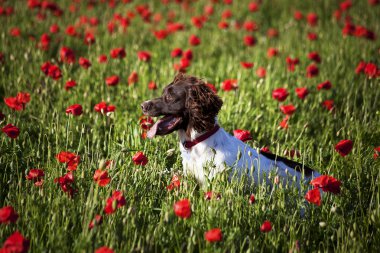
left=146, top=115, right=183, bottom=139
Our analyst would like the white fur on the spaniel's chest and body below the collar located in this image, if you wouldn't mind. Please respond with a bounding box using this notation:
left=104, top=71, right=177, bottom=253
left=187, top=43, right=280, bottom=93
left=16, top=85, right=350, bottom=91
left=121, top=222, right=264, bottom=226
left=178, top=128, right=319, bottom=188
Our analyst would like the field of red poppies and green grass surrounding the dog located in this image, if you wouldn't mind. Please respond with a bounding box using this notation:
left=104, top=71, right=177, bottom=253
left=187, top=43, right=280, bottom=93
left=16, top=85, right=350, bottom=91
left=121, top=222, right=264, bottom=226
left=0, top=0, right=380, bottom=253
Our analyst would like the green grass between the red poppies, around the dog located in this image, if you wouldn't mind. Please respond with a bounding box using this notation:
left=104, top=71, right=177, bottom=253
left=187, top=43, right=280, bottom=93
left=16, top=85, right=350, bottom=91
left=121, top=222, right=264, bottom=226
left=0, top=0, right=380, bottom=252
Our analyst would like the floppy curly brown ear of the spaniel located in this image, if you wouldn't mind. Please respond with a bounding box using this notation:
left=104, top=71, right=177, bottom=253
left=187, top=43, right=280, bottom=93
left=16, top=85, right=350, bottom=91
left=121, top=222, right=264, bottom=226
left=186, top=82, right=223, bottom=136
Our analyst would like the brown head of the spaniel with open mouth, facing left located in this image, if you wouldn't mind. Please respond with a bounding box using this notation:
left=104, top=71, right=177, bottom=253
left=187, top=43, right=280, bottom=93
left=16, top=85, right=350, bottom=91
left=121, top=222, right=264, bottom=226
left=141, top=73, right=223, bottom=138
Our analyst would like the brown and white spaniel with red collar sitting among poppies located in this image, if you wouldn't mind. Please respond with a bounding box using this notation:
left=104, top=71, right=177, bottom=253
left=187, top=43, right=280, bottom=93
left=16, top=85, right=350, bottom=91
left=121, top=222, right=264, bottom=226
left=141, top=73, right=320, bottom=189
